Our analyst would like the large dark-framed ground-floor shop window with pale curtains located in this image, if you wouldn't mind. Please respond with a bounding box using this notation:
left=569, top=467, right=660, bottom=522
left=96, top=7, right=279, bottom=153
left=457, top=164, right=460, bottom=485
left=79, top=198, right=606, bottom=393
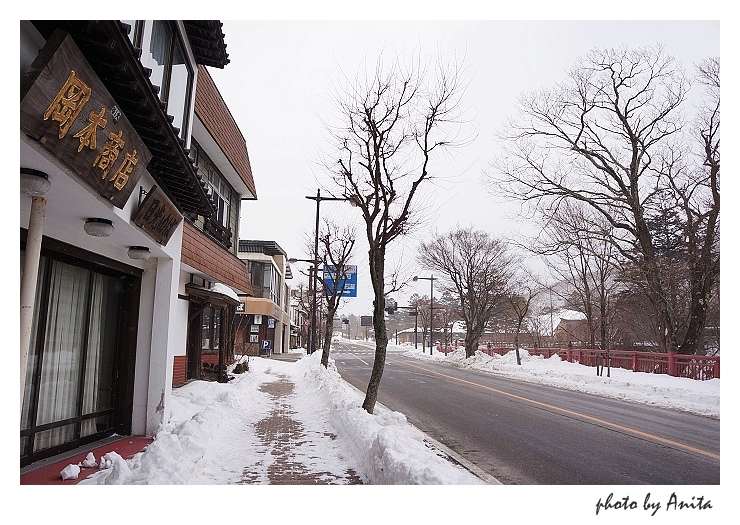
left=20, top=251, right=126, bottom=461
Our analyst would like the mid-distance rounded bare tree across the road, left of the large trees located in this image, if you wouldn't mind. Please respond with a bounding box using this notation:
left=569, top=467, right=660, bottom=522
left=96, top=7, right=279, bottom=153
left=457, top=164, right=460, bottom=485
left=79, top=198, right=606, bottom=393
left=419, top=226, right=513, bottom=357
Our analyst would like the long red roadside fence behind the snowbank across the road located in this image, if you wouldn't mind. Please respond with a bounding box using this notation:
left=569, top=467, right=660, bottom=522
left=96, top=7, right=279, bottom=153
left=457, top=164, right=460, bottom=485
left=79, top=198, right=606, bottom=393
left=437, top=345, right=719, bottom=381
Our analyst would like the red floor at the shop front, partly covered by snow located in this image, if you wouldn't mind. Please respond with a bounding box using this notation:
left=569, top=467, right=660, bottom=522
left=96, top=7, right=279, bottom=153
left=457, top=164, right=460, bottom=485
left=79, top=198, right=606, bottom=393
left=21, top=436, right=152, bottom=485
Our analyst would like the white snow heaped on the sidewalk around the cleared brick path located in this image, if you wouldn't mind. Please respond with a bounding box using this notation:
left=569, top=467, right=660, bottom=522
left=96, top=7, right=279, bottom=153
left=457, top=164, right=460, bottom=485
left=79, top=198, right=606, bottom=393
left=80, top=352, right=482, bottom=485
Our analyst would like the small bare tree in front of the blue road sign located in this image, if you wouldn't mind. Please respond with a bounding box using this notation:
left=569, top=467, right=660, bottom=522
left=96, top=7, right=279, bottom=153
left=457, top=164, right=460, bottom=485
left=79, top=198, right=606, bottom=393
left=319, top=220, right=356, bottom=368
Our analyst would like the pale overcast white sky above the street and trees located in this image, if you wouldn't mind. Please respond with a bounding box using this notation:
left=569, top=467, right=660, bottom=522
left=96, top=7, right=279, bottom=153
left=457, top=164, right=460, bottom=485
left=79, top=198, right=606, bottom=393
left=201, top=16, right=720, bottom=315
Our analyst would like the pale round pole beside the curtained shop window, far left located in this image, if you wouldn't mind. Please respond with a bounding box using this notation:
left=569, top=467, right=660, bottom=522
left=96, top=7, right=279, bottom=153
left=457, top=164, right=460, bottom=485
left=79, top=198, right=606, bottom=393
left=20, top=196, right=46, bottom=413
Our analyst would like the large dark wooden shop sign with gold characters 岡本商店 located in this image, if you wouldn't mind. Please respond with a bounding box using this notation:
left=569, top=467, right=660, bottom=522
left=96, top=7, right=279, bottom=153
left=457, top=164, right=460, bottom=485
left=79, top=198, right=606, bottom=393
left=21, top=30, right=151, bottom=208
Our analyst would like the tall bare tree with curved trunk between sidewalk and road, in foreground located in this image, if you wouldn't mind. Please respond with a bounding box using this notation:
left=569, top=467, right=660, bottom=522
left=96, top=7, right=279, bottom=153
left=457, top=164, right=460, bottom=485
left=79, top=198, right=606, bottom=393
left=329, top=50, right=472, bottom=413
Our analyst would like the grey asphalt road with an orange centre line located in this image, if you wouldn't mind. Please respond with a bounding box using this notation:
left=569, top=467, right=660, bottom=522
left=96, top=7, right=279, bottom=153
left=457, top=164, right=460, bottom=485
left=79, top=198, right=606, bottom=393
left=332, top=342, right=720, bottom=485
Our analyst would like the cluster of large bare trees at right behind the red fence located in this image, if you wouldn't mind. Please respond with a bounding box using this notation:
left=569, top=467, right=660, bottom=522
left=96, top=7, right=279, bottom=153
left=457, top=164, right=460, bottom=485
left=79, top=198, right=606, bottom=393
left=487, top=47, right=720, bottom=354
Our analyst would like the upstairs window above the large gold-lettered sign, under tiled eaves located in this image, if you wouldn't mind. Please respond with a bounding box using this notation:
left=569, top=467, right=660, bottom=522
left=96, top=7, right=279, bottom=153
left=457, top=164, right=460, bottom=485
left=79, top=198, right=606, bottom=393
left=134, top=20, right=195, bottom=140
